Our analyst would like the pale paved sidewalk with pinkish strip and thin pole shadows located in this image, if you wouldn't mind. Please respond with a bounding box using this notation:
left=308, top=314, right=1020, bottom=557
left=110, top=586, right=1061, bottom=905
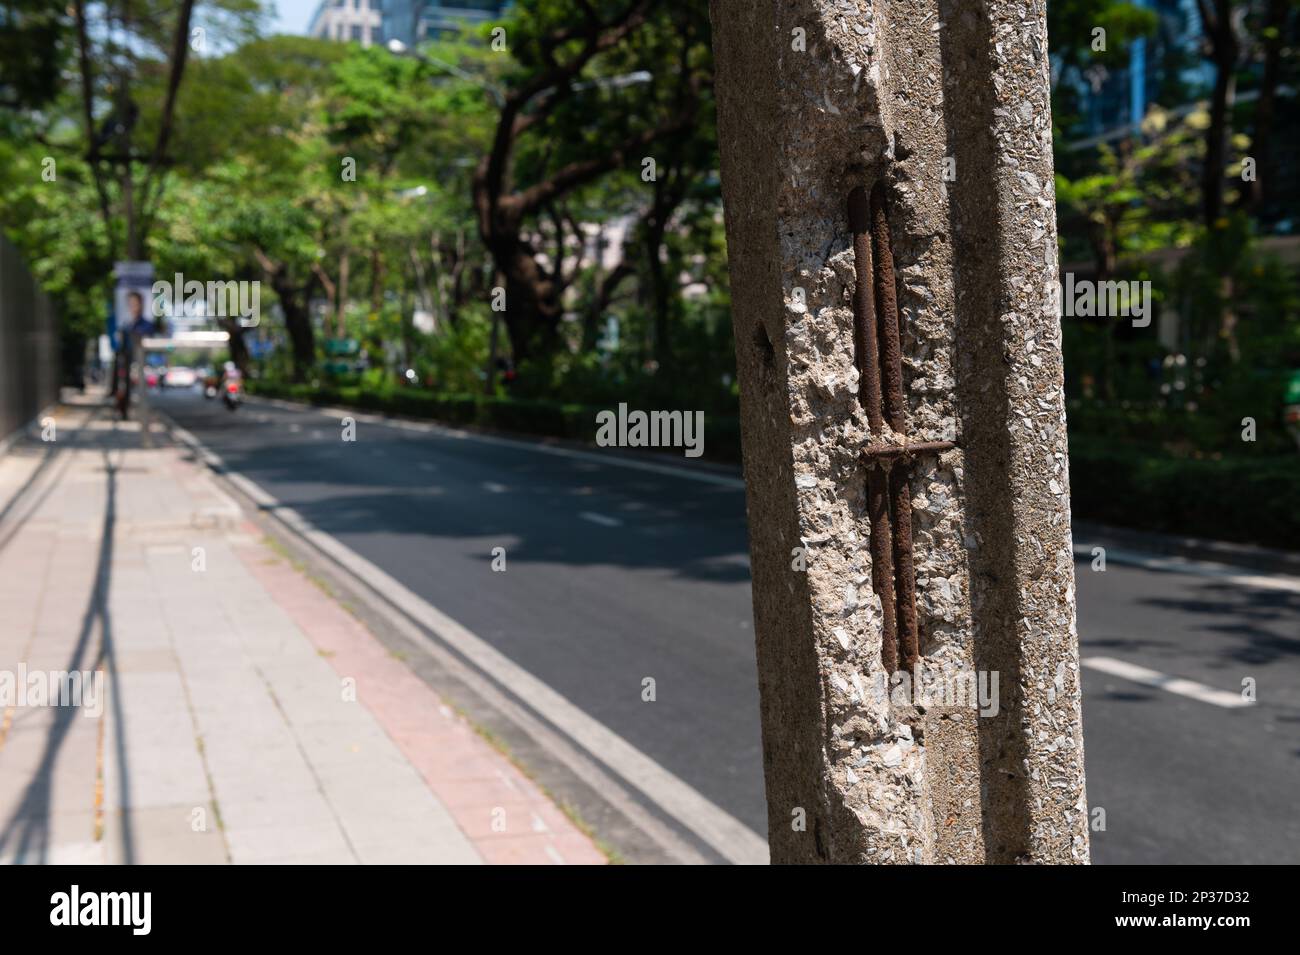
left=0, top=394, right=606, bottom=864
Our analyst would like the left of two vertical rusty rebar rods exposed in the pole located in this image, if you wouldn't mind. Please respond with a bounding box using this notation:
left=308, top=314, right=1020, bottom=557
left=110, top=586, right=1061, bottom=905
left=849, top=186, right=898, bottom=673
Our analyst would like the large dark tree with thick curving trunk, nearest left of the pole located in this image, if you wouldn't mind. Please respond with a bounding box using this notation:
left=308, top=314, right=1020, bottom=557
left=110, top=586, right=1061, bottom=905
left=473, top=0, right=709, bottom=361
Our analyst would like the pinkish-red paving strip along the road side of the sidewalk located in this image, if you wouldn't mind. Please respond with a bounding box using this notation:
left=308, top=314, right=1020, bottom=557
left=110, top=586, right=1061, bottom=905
left=235, top=524, right=607, bottom=865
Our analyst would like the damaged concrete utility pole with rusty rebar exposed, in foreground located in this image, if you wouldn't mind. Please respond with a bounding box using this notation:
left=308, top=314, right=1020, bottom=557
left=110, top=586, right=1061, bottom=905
left=712, top=0, right=1088, bottom=863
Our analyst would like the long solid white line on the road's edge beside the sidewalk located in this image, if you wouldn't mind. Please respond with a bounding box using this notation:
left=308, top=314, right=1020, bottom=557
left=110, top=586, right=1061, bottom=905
left=172, top=420, right=770, bottom=865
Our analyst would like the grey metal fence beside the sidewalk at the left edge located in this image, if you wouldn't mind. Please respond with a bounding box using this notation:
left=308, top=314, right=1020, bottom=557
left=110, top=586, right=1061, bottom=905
left=0, top=235, right=60, bottom=440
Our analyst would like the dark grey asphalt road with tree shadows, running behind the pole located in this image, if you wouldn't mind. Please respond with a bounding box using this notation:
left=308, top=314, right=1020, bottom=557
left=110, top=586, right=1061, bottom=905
left=151, top=392, right=1300, bottom=863
